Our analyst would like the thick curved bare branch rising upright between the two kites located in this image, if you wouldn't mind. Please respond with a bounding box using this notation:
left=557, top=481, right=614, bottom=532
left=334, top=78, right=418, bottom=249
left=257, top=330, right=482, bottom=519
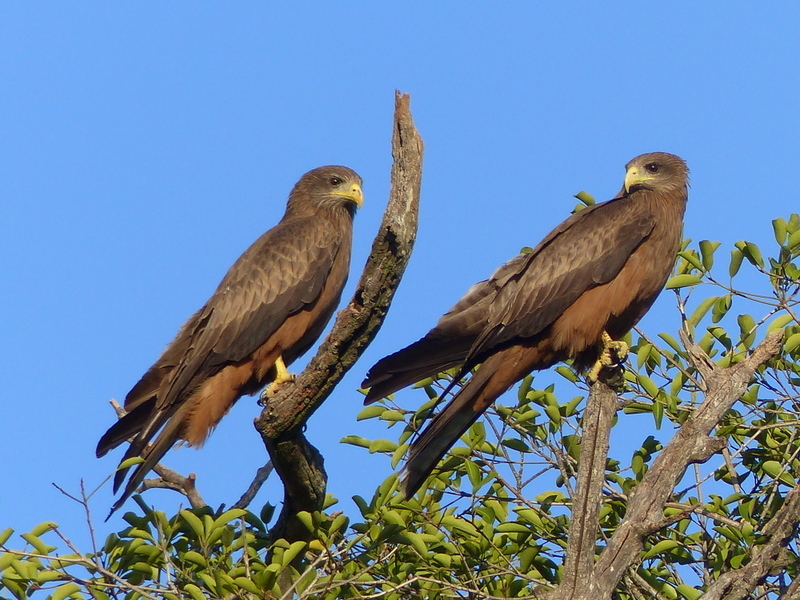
left=255, top=92, right=423, bottom=541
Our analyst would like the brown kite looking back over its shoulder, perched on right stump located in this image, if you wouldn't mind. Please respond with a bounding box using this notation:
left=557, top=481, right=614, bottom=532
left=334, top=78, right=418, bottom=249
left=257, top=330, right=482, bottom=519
left=362, top=152, right=689, bottom=497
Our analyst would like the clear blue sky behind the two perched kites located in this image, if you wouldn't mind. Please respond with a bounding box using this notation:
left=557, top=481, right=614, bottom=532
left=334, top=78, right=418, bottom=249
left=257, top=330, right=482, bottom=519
left=0, top=1, right=800, bottom=547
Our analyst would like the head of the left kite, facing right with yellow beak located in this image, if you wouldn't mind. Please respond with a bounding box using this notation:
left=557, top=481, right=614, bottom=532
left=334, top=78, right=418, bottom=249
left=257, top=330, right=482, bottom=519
left=289, top=165, right=364, bottom=213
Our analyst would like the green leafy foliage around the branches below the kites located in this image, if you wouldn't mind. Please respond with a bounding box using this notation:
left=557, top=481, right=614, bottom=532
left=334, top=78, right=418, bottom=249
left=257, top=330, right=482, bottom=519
left=0, top=213, right=800, bottom=600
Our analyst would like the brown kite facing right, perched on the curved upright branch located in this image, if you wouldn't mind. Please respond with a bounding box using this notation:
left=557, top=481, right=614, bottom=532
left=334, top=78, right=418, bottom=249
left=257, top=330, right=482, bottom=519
left=97, top=166, right=363, bottom=513
